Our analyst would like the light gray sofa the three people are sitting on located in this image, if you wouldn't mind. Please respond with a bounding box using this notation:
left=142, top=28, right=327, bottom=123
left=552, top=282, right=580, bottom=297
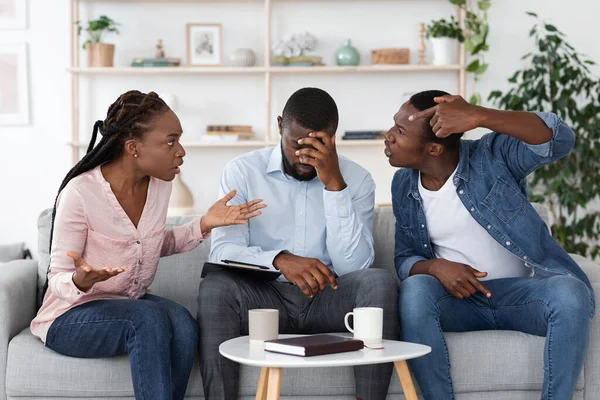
left=0, top=207, right=600, bottom=400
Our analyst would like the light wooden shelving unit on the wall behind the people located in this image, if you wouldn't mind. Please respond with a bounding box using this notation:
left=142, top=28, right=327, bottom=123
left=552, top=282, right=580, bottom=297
left=68, top=0, right=466, bottom=163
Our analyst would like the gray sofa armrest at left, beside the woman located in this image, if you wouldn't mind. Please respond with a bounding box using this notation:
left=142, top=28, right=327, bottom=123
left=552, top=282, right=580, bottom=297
left=0, top=260, right=37, bottom=399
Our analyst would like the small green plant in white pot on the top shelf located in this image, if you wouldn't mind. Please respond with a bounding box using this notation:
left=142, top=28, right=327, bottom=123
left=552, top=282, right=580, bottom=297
left=425, top=17, right=465, bottom=65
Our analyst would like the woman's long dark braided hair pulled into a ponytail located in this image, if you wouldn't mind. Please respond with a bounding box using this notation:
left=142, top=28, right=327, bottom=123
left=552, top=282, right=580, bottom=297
left=40, top=90, right=169, bottom=302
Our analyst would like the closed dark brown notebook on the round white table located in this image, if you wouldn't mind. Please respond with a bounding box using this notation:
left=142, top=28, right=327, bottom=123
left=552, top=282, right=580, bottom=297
left=265, top=335, right=364, bottom=357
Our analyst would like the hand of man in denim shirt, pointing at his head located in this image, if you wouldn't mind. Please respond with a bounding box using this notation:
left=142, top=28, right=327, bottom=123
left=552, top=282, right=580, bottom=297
left=408, top=96, right=485, bottom=138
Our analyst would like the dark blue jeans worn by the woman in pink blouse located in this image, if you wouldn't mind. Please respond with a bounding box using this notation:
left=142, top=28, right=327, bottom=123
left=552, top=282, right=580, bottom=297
left=46, top=294, right=198, bottom=400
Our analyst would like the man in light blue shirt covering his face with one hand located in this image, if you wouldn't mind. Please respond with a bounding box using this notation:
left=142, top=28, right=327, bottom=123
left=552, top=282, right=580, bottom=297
left=198, top=88, right=399, bottom=399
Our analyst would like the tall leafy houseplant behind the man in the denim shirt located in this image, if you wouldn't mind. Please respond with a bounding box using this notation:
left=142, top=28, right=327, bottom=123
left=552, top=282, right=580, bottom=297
left=489, top=13, right=600, bottom=257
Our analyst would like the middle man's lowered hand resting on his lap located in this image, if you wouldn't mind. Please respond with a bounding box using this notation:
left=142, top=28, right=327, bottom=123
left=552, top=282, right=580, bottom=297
left=273, top=253, right=337, bottom=298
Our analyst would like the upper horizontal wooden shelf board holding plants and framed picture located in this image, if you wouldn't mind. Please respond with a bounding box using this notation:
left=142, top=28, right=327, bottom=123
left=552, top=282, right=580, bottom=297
left=68, top=64, right=461, bottom=75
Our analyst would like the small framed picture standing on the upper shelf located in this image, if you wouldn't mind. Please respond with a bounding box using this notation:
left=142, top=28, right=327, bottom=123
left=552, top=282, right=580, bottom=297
left=186, top=22, right=223, bottom=67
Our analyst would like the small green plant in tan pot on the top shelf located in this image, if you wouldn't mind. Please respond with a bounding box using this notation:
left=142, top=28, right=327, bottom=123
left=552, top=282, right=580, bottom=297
left=76, top=15, right=119, bottom=67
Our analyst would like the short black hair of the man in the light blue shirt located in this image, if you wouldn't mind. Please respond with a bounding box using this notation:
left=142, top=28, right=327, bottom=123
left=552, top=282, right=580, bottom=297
left=281, top=88, right=339, bottom=135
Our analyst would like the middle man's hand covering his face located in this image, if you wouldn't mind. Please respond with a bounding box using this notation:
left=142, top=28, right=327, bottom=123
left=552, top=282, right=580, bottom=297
left=296, top=132, right=346, bottom=192
